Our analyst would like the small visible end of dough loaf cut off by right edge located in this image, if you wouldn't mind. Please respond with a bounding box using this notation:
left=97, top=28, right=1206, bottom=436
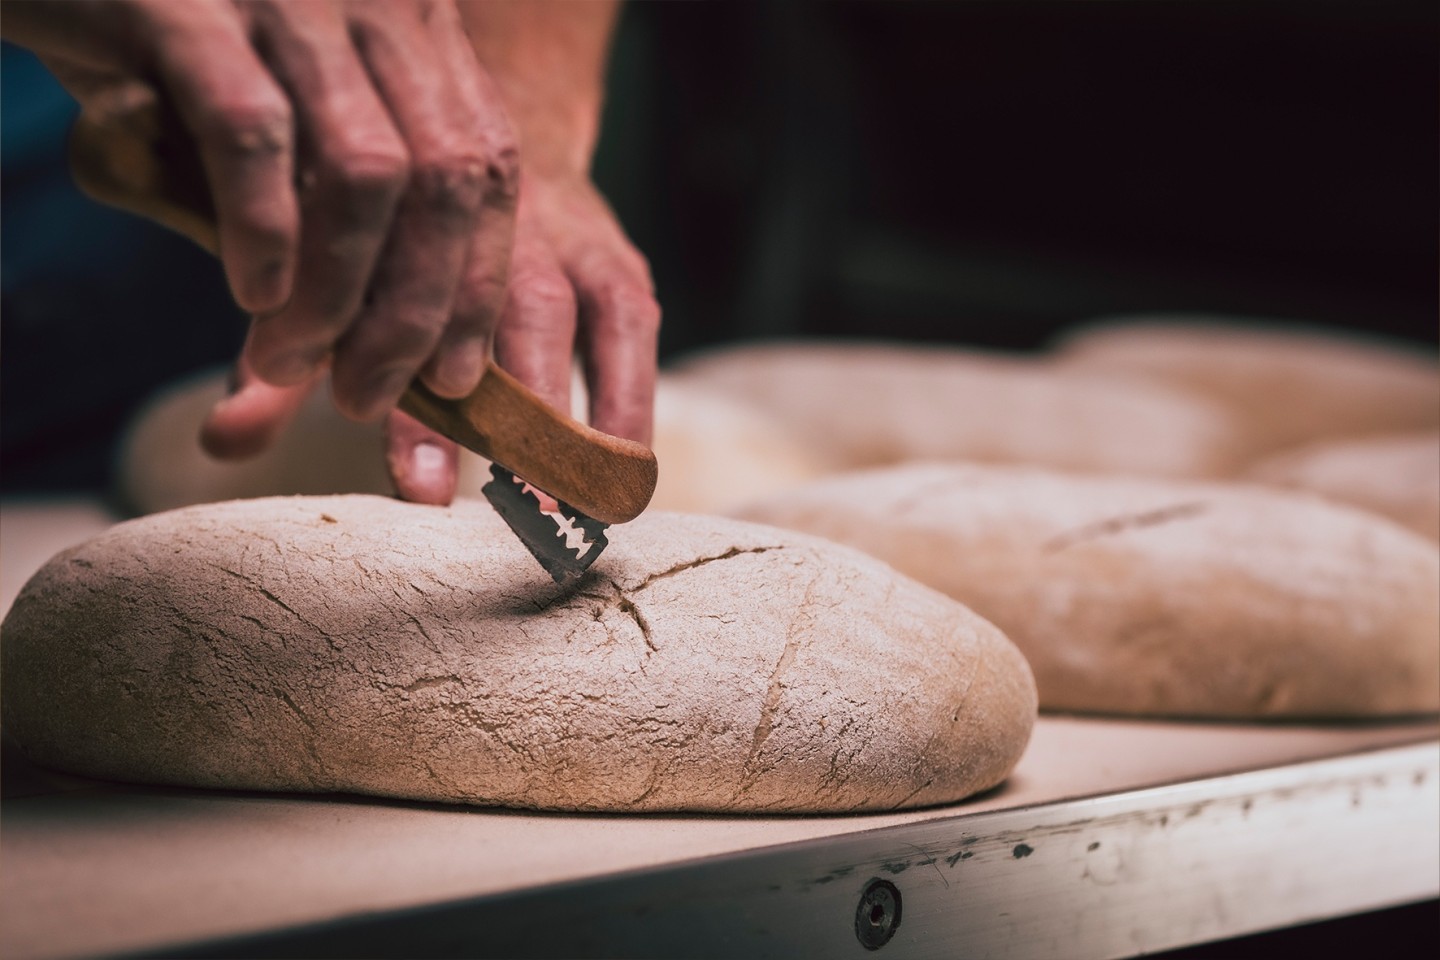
left=1247, top=432, right=1440, bottom=540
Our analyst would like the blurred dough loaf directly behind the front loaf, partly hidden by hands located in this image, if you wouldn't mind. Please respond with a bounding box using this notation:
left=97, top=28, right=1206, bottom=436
left=118, top=370, right=822, bottom=514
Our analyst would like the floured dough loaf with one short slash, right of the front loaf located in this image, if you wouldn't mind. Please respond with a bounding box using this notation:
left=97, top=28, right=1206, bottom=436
left=746, top=465, right=1440, bottom=718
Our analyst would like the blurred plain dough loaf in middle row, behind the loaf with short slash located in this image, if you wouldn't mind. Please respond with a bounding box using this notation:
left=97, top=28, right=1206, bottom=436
left=674, top=341, right=1234, bottom=476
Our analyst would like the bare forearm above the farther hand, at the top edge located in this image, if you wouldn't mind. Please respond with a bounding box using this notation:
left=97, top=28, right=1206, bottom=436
left=461, top=0, right=619, bottom=177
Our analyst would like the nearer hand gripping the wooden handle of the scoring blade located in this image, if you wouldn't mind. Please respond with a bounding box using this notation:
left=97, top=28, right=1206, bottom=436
left=4, top=0, right=518, bottom=420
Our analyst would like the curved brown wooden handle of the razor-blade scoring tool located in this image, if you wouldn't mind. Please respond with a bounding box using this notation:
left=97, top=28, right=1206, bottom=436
left=71, top=110, right=658, bottom=524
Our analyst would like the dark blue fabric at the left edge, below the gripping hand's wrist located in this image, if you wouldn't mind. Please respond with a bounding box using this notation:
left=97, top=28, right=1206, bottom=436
left=0, top=45, right=245, bottom=492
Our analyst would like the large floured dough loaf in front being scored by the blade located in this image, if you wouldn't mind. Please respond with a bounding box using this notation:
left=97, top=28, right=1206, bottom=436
left=0, top=497, right=1035, bottom=812
